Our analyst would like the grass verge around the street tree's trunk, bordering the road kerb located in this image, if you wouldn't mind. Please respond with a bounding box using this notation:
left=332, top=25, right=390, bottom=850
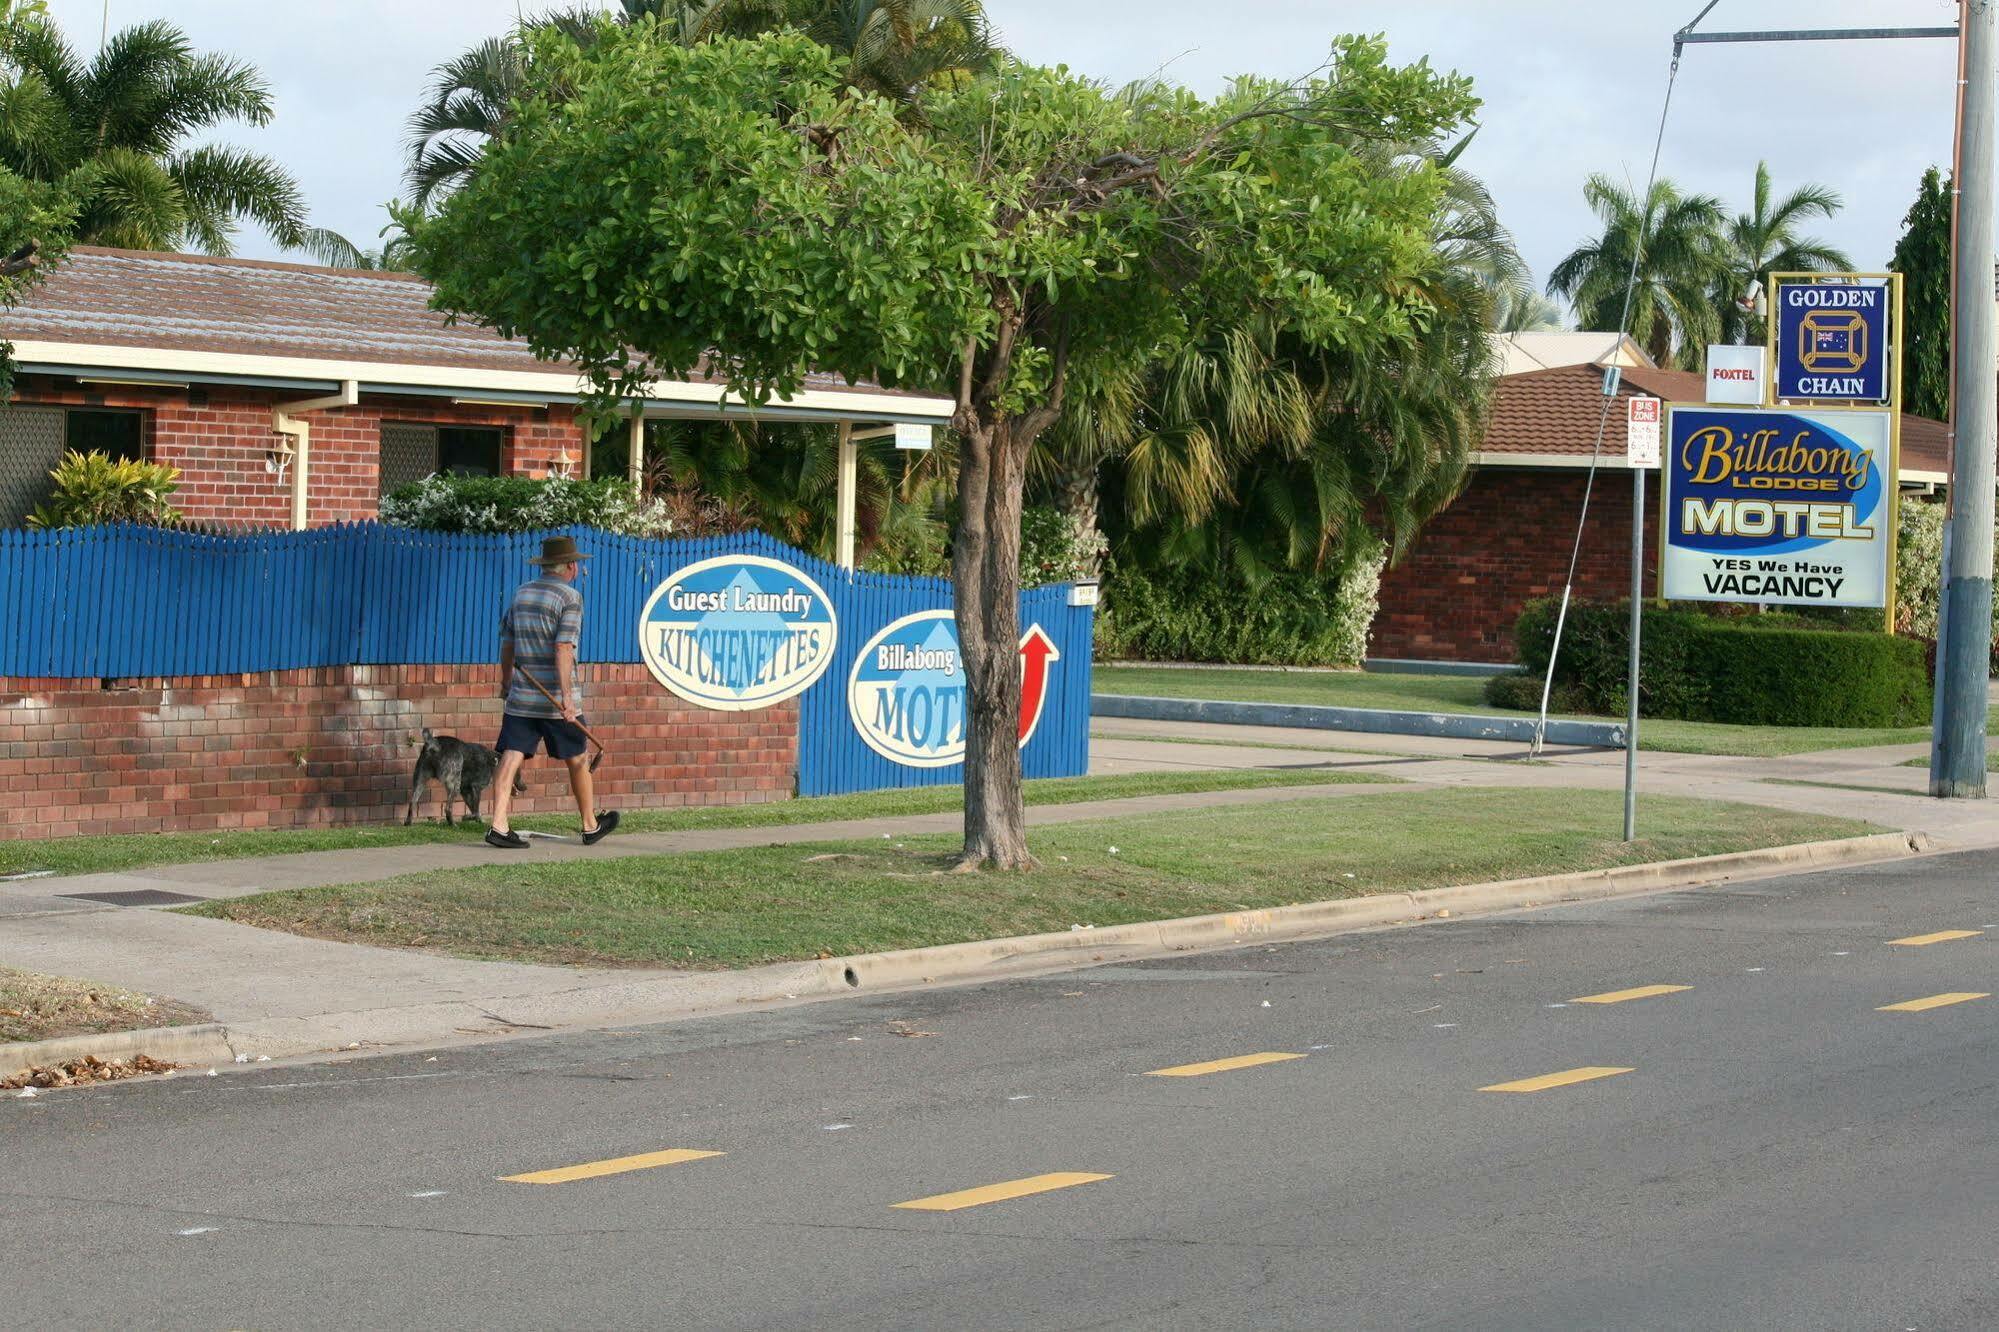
left=184, top=788, right=1873, bottom=968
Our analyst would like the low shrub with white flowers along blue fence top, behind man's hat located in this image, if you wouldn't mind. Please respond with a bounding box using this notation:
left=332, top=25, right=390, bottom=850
left=382, top=476, right=687, bottom=538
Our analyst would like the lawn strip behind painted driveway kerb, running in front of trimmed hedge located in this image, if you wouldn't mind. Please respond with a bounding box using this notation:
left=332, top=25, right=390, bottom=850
left=1091, top=666, right=1999, bottom=758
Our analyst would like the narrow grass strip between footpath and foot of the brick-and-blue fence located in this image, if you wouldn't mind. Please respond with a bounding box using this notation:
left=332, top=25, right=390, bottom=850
left=0, top=770, right=1395, bottom=874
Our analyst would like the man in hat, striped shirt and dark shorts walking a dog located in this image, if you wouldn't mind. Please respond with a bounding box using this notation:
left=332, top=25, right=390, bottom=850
left=486, top=536, right=618, bottom=850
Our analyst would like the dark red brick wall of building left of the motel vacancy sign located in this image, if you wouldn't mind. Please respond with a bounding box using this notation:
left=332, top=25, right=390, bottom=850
left=1367, top=468, right=1659, bottom=662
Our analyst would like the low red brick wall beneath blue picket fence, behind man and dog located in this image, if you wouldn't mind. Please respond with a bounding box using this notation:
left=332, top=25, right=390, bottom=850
left=0, top=664, right=798, bottom=838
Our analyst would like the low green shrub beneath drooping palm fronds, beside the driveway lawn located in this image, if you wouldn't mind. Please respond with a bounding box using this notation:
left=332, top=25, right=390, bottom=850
left=1097, top=548, right=1383, bottom=666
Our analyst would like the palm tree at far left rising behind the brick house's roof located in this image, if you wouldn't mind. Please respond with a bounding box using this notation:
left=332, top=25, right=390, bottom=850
left=0, top=18, right=306, bottom=254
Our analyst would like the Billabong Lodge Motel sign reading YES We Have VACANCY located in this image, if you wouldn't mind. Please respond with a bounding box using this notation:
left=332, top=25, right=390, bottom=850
left=1659, top=406, right=1895, bottom=606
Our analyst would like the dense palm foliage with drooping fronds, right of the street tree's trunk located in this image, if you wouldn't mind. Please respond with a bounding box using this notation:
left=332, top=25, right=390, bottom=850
left=1063, top=140, right=1503, bottom=584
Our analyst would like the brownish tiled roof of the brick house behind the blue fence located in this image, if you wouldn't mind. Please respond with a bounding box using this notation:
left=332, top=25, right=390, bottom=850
left=0, top=246, right=935, bottom=396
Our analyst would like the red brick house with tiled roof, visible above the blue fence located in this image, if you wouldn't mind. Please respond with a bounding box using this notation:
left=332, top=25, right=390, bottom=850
left=0, top=246, right=952, bottom=528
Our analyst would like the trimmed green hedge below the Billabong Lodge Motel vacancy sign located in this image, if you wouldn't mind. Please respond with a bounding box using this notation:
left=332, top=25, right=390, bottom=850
left=1487, top=600, right=1929, bottom=726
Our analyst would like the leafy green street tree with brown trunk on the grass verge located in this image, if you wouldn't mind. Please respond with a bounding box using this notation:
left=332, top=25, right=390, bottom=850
left=402, top=24, right=1475, bottom=868
